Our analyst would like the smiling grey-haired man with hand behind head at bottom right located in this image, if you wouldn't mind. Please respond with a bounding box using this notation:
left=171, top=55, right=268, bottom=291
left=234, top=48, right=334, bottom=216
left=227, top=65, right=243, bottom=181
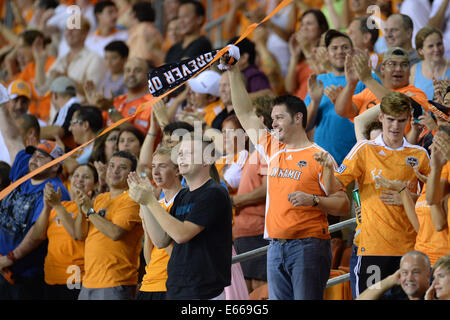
left=356, top=251, right=431, bottom=300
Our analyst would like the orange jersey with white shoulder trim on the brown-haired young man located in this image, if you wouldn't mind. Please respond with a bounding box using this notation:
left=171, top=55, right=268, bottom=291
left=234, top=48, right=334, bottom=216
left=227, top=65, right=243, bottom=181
left=335, top=134, right=430, bottom=256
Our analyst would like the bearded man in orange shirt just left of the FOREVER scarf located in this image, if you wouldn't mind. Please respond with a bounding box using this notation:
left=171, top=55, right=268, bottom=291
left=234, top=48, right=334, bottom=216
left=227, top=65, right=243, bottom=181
left=103, top=58, right=152, bottom=134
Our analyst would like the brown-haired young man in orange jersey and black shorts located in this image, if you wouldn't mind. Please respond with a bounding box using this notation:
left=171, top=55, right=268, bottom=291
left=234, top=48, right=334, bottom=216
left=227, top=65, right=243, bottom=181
left=335, top=92, right=430, bottom=295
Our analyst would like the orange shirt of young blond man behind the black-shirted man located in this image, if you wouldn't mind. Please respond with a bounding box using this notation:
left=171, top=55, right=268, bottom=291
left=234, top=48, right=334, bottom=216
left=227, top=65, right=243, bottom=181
left=139, top=193, right=178, bottom=292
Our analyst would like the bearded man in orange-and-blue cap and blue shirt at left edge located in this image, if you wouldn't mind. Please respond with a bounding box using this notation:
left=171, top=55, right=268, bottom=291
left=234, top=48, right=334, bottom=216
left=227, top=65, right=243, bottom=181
left=0, top=84, right=70, bottom=300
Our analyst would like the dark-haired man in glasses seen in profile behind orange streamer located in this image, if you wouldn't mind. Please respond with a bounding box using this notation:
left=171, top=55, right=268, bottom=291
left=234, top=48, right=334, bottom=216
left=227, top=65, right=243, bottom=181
left=63, top=106, right=103, bottom=175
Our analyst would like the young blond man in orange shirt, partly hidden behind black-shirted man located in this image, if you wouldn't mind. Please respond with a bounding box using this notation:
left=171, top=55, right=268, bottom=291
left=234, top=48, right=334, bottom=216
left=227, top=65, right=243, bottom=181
left=128, top=147, right=182, bottom=300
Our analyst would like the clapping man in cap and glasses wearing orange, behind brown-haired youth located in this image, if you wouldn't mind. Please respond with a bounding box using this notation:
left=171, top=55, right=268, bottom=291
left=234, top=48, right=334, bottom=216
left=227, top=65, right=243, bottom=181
left=335, top=47, right=428, bottom=119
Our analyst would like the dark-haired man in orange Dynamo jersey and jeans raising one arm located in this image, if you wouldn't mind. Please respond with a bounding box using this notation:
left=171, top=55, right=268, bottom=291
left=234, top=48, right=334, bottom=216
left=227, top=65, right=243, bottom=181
left=230, top=59, right=349, bottom=300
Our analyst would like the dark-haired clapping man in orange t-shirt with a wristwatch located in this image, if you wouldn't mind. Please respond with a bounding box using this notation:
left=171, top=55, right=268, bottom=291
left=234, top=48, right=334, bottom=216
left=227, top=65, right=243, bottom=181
left=75, top=151, right=143, bottom=300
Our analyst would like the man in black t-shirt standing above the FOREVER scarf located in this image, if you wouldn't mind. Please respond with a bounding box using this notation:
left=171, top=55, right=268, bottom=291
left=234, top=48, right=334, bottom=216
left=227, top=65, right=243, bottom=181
left=164, top=0, right=212, bottom=63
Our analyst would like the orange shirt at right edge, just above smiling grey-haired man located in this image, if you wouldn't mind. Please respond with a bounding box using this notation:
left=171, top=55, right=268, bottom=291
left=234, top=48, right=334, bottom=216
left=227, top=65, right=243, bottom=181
left=414, top=185, right=450, bottom=265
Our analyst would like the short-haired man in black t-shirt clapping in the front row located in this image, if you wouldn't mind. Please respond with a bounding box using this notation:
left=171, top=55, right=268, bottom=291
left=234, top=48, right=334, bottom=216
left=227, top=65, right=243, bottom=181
left=129, top=134, right=232, bottom=300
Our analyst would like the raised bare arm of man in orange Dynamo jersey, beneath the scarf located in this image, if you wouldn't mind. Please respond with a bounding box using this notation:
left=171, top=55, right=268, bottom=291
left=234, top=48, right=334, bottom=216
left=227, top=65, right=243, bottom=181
left=227, top=65, right=265, bottom=145
